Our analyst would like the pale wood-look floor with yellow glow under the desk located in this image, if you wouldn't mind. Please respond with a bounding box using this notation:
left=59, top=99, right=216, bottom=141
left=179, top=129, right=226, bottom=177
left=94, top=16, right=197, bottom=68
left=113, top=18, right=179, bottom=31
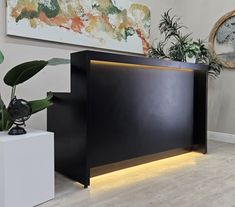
left=39, top=141, right=235, bottom=207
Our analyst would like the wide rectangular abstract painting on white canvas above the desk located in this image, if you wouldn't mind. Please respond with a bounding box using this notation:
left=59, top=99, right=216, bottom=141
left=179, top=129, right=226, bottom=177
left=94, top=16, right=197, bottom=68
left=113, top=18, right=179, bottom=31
left=7, top=0, right=151, bottom=53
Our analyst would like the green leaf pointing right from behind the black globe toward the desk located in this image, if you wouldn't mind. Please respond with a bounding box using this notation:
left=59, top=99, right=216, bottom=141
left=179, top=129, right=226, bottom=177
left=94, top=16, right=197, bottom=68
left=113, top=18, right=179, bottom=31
left=29, top=92, right=53, bottom=114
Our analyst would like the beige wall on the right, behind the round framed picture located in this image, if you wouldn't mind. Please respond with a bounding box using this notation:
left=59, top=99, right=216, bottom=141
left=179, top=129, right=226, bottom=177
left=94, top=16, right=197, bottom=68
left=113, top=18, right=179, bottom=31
left=170, top=0, right=235, bottom=134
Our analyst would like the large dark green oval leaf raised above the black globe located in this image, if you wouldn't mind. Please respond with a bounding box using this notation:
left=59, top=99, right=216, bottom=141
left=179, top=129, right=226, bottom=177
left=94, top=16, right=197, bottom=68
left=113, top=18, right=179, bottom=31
left=4, top=60, right=48, bottom=87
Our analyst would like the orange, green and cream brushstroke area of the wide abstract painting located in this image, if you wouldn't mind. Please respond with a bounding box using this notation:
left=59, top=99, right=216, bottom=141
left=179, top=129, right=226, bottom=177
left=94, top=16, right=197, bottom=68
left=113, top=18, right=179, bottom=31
left=8, top=0, right=150, bottom=53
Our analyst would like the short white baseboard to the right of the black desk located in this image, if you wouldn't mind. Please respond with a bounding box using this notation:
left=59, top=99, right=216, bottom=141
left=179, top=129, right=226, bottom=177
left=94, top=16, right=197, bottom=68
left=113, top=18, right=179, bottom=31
left=207, top=131, right=235, bottom=144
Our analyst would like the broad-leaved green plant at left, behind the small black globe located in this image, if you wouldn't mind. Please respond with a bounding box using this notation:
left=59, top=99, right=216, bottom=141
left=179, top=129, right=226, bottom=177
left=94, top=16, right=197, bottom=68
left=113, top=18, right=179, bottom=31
left=0, top=51, right=69, bottom=131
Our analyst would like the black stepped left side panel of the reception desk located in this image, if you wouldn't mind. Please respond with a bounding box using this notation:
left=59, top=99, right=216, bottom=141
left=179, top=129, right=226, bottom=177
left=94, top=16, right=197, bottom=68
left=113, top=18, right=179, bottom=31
left=48, top=53, right=89, bottom=187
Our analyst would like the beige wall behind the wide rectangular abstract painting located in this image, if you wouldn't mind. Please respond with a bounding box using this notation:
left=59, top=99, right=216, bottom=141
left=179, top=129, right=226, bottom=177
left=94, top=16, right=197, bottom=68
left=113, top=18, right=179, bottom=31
left=0, top=0, right=176, bottom=129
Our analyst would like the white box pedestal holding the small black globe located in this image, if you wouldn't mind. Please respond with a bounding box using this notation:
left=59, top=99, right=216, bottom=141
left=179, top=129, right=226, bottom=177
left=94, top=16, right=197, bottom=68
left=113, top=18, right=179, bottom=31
left=0, top=130, right=54, bottom=207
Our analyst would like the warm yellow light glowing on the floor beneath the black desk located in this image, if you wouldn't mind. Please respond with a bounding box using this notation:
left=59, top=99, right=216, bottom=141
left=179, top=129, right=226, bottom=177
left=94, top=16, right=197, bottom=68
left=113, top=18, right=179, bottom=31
left=90, top=152, right=203, bottom=196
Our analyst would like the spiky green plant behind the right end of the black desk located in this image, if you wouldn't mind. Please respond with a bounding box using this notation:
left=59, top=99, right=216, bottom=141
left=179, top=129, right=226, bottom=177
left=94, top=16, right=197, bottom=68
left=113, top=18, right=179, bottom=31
left=148, top=9, right=223, bottom=78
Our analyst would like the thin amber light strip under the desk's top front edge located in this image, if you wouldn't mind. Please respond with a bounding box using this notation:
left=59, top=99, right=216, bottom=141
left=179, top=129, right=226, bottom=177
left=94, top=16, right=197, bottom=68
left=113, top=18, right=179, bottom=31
left=91, top=60, right=193, bottom=72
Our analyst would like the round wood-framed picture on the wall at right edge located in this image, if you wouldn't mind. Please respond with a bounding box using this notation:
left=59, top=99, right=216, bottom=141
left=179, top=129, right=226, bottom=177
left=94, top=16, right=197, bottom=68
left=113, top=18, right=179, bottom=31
left=209, top=11, right=235, bottom=68
